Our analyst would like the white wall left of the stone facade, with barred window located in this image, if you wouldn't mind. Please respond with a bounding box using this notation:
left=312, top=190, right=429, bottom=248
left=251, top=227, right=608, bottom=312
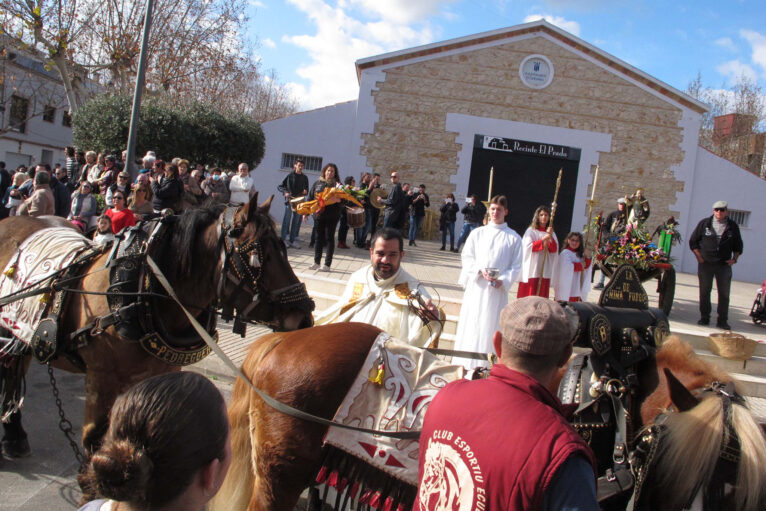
left=251, top=101, right=361, bottom=208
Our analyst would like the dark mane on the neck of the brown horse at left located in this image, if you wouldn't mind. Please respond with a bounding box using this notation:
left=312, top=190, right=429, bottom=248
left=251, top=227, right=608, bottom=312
left=160, top=202, right=226, bottom=280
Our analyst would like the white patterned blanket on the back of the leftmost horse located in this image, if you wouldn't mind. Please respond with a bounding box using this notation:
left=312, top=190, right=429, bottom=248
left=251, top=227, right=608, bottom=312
left=0, top=227, right=94, bottom=345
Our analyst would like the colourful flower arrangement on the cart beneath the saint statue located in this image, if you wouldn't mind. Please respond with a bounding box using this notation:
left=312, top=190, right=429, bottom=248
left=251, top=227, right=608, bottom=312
left=599, top=224, right=670, bottom=270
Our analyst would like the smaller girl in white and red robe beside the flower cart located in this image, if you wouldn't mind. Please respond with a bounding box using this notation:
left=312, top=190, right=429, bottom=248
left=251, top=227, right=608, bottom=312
left=551, top=232, right=593, bottom=302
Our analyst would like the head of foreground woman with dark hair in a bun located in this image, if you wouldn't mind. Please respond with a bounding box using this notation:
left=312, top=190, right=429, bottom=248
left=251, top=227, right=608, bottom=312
left=80, top=372, right=231, bottom=511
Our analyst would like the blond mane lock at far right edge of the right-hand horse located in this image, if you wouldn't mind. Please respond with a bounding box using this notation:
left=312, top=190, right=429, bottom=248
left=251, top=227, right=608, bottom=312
left=731, top=406, right=766, bottom=509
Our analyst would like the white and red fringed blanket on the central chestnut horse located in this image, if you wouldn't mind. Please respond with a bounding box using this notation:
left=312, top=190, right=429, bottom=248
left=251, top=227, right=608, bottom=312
left=317, top=333, right=466, bottom=509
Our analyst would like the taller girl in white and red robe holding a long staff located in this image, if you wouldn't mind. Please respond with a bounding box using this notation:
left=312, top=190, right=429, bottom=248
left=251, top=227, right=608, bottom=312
left=516, top=206, right=559, bottom=298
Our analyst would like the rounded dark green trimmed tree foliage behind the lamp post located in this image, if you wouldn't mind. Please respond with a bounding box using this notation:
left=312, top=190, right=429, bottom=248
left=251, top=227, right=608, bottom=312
left=72, top=95, right=265, bottom=169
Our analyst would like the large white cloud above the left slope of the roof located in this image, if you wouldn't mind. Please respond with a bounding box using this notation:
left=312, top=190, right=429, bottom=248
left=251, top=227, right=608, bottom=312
left=282, top=0, right=452, bottom=108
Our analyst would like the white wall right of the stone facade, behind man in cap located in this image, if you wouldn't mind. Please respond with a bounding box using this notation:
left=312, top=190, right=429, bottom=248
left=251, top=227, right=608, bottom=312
left=684, top=147, right=766, bottom=284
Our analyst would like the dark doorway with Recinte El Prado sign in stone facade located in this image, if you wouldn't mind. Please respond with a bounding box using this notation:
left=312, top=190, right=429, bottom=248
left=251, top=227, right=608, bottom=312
left=468, top=135, right=582, bottom=241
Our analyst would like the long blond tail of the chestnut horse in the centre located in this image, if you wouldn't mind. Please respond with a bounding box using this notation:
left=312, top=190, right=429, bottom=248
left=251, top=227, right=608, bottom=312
left=207, top=334, right=282, bottom=511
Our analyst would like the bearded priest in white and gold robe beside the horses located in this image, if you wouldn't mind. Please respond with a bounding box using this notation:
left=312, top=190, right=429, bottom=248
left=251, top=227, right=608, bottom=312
left=314, top=228, right=444, bottom=347
